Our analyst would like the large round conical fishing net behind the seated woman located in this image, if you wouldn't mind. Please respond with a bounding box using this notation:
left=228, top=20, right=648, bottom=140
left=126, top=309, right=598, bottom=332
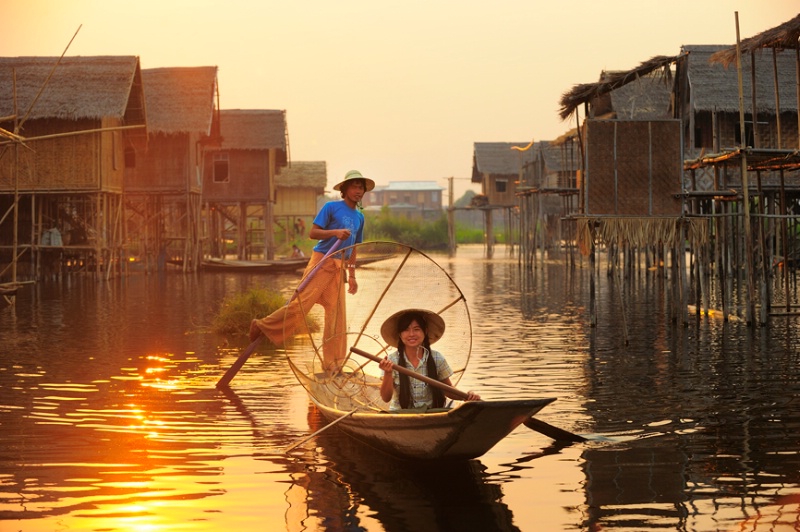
left=283, top=242, right=472, bottom=410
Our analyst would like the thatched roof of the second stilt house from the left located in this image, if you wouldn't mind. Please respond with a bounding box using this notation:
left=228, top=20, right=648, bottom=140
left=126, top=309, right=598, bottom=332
left=142, top=66, right=217, bottom=135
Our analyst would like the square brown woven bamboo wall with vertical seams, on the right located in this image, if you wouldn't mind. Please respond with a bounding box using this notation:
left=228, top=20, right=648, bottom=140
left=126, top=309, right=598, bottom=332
left=584, top=120, right=683, bottom=216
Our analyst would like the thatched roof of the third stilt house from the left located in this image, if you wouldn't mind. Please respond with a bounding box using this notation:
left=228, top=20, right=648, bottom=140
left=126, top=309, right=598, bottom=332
left=219, top=109, right=287, bottom=152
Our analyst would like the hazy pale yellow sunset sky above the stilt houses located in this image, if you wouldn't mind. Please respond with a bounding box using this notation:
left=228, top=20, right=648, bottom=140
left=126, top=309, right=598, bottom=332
left=0, top=0, right=800, bottom=197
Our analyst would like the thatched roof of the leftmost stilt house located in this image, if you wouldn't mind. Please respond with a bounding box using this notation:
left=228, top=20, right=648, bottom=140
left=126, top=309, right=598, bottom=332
left=0, top=56, right=144, bottom=125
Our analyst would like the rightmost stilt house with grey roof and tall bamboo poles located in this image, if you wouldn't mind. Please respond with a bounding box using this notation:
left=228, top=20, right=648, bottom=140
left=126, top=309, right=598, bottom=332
left=676, top=15, right=800, bottom=324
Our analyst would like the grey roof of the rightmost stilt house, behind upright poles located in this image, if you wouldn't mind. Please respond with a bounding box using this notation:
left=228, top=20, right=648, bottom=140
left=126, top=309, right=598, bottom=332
left=678, top=45, right=797, bottom=113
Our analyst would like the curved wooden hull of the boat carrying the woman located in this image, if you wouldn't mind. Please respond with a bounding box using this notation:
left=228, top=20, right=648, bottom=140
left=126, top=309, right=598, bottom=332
left=311, top=396, right=555, bottom=460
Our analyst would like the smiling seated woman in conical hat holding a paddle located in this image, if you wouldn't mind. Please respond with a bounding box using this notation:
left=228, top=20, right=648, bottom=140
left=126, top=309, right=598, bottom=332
left=380, top=309, right=480, bottom=410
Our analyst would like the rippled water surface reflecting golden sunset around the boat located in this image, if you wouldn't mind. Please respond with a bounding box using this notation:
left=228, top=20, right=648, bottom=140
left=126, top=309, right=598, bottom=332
left=0, top=247, right=800, bottom=532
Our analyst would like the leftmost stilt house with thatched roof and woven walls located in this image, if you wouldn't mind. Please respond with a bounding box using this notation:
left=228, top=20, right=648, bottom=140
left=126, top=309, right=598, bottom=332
left=0, top=56, right=146, bottom=280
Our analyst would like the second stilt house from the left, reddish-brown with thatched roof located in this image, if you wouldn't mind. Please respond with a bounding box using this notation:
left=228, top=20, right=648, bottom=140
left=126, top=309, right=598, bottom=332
left=125, top=66, right=219, bottom=271
